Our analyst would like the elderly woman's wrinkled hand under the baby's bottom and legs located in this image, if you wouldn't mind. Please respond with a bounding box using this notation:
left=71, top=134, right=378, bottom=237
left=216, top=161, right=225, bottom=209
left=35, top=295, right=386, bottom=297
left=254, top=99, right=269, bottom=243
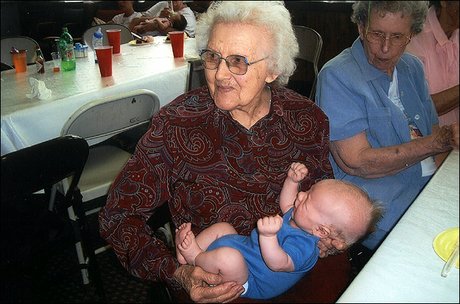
left=174, top=265, right=244, bottom=303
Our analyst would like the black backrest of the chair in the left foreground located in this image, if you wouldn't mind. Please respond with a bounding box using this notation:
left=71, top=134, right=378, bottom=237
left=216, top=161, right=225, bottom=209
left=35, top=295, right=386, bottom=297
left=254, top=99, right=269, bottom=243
left=1, top=135, right=89, bottom=203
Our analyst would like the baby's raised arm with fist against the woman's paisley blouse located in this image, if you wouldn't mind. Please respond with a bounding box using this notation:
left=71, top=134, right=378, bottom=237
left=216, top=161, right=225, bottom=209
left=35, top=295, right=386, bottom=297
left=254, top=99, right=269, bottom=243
left=280, top=163, right=308, bottom=214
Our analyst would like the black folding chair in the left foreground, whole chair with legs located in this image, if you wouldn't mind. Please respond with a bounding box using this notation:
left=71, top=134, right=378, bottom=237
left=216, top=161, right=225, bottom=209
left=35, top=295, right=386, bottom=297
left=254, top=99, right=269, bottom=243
left=0, top=135, right=105, bottom=302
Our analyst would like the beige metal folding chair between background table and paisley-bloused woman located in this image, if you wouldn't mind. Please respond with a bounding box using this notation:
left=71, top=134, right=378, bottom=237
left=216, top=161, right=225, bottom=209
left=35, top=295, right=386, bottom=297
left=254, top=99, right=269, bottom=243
left=61, top=89, right=160, bottom=215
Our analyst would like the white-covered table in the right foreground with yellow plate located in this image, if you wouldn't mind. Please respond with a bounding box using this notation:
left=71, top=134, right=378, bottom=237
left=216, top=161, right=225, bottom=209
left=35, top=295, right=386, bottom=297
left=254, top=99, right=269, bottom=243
left=338, top=151, right=459, bottom=303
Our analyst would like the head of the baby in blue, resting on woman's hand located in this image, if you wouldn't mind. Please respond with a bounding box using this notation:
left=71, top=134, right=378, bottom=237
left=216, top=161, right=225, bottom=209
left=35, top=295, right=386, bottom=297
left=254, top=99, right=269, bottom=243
left=292, top=179, right=383, bottom=245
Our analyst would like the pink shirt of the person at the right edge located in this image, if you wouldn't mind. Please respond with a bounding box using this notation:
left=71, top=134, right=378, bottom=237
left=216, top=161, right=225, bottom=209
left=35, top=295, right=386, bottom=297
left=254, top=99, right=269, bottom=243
left=406, top=6, right=459, bottom=125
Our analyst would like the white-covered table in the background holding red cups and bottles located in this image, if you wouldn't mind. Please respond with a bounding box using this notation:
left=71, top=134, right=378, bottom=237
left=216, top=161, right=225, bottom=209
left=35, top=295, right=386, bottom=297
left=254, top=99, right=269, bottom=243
left=1, top=36, right=197, bottom=155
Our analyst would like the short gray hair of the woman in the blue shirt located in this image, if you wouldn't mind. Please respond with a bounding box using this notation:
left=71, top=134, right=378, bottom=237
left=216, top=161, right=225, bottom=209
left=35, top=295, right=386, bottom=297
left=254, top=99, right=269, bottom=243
left=351, top=1, right=429, bottom=34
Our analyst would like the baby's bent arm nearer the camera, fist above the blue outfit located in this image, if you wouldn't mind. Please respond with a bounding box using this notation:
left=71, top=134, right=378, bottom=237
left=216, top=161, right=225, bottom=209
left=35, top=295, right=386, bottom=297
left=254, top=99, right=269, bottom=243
left=257, top=215, right=294, bottom=271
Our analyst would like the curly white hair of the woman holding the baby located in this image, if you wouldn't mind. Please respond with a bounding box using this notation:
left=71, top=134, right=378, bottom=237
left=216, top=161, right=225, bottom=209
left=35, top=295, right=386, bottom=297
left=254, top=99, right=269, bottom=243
left=195, top=1, right=299, bottom=86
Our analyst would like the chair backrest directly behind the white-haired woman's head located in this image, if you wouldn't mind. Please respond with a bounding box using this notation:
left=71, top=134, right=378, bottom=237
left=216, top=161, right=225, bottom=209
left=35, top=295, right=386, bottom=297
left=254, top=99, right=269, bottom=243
left=293, top=25, right=323, bottom=100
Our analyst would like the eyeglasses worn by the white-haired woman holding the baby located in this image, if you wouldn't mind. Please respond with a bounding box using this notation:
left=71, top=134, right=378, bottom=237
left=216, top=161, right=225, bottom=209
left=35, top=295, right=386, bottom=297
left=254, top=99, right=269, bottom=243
left=200, top=50, right=268, bottom=75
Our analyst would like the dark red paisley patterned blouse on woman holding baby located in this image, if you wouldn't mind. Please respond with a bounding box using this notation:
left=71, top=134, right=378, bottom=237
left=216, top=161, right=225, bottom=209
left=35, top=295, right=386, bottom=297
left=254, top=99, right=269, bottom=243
left=99, top=86, right=333, bottom=289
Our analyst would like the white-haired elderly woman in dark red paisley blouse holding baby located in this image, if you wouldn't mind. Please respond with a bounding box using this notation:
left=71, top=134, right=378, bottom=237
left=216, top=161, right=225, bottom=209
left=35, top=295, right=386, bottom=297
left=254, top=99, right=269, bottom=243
left=99, top=1, right=344, bottom=302
